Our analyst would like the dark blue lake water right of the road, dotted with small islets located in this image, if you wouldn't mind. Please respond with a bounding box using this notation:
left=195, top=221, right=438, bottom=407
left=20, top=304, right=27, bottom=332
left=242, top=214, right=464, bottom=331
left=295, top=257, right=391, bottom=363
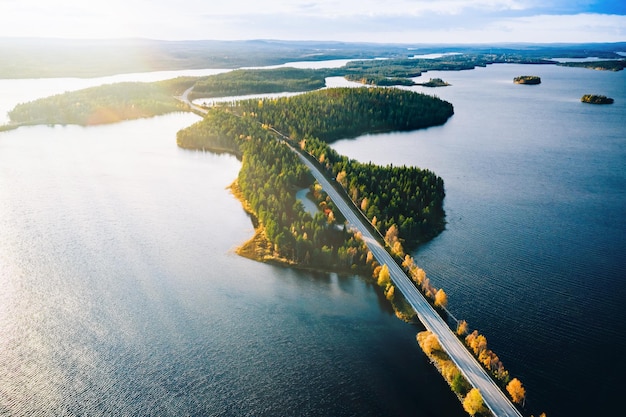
left=333, top=64, right=626, bottom=416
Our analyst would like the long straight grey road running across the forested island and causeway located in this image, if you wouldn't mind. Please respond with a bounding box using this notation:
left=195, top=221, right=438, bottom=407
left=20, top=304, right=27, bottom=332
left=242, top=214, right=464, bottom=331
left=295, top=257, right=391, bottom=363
left=177, top=87, right=523, bottom=417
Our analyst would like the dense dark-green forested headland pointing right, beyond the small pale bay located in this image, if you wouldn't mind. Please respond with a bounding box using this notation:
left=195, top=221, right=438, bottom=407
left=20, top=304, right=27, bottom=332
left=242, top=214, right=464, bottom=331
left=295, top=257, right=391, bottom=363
left=237, top=88, right=454, bottom=142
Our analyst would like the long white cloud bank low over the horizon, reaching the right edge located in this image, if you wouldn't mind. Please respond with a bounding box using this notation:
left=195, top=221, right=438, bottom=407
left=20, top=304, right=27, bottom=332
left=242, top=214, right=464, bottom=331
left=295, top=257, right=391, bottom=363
left=189, top=12, right=626, bottom=43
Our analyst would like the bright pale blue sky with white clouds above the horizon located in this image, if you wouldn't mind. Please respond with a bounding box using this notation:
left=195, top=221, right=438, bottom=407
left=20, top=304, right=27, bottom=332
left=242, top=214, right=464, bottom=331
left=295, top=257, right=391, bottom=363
left=0, top=0, right=626, bottom=44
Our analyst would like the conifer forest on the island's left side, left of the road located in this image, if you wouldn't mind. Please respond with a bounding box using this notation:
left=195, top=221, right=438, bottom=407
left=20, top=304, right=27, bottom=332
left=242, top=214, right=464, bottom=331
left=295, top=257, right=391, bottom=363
left=177, top=108, right=367, bottom=270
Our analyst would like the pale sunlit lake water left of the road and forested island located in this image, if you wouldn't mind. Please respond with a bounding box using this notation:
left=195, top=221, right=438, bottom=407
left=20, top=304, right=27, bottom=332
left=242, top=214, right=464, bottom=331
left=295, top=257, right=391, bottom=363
left=0, top=63, right=465, bottom=417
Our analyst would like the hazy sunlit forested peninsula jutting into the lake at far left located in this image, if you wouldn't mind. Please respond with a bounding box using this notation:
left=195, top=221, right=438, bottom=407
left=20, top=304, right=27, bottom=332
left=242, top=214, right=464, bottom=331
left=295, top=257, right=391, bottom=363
left=9, top=82, right=185, bottom=125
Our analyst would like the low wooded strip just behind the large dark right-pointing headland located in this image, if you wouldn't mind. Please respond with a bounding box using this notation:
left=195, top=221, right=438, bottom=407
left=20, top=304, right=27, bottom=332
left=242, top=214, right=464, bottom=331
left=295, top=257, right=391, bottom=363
left=191, top=68, right=328, bottom=98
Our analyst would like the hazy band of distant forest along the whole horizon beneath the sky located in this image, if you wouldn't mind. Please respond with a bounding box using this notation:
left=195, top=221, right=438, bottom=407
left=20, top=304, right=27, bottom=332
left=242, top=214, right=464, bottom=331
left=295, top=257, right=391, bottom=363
left=0, top=38, right=626, bottom=78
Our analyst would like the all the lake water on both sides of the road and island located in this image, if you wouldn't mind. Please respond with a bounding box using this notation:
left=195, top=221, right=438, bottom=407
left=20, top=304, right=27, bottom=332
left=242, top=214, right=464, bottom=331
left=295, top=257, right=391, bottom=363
left=0, top=60, right=626, bottom=417
